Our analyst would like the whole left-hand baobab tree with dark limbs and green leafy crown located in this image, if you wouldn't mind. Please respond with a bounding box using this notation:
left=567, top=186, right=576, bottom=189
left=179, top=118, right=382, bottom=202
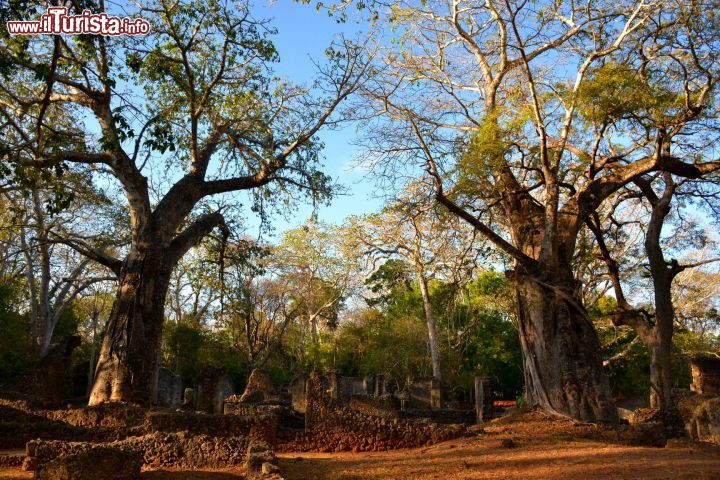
left=0, top=0, right=366, bottom=405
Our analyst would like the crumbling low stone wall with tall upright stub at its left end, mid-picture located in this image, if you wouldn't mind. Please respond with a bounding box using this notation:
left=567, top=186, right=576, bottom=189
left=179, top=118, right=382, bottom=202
left=276, top=373, right=465, bottom=452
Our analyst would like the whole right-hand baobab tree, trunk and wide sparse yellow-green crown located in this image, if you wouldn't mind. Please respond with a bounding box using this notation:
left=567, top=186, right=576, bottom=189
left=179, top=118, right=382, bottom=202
left=364, top=0, right=720, bottom=422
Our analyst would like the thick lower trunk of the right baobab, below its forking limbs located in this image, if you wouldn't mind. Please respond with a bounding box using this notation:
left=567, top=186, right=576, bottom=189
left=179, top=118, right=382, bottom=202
left=516, top=276, right=617, bottom=423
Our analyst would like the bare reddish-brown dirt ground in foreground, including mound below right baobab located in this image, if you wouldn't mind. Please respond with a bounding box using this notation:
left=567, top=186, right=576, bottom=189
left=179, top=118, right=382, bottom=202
left=0, top=413, right=720, bottom=480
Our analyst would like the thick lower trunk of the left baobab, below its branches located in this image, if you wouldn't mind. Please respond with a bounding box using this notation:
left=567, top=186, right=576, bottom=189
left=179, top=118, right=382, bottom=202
left=89, top=248, right=174, bottom=405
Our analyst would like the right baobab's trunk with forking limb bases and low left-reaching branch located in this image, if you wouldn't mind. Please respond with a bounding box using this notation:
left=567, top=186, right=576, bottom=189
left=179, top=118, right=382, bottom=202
left=436, top=182, right=618, bottom=423
